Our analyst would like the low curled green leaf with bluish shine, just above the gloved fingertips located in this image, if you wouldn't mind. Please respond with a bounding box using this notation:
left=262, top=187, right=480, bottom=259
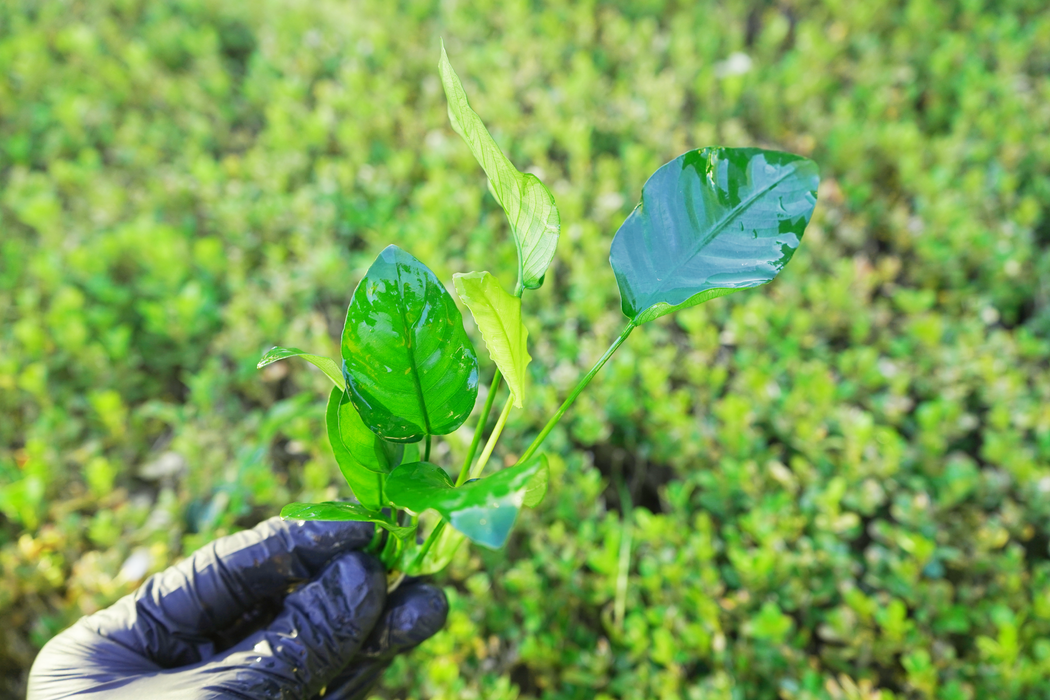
left=386, top=454, right=546, bottom=549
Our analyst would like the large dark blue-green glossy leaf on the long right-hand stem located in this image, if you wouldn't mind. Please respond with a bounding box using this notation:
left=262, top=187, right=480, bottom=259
left=609, top=148, right=820, bottom=324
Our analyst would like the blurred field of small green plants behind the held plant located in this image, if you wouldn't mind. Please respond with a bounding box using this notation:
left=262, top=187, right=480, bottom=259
left=0, top=0, right=1050, bottom=700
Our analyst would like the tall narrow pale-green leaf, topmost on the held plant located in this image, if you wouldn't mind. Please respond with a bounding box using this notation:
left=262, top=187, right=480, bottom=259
left=438, top=44, right=562, bottom=290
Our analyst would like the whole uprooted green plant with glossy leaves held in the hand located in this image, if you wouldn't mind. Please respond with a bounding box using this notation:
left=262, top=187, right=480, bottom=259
left=258, top=47, right=819, bottom=587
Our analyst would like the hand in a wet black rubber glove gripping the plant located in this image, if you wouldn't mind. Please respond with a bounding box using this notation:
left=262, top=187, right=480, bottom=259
left=28, top=518, right=448, bottom=700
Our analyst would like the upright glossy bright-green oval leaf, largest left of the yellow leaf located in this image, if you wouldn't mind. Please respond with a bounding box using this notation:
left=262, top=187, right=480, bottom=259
left=342, top=246, right=478, bottom=443
